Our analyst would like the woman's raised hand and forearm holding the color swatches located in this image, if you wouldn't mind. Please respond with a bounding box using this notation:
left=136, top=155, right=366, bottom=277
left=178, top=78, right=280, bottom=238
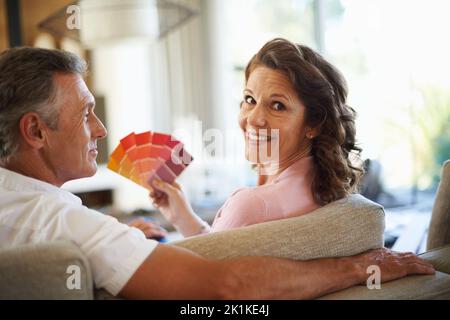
left=150, top=180, right=209, bottom=237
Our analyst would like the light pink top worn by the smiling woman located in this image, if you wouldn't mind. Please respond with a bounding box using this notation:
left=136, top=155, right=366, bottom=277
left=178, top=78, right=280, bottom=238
left=211, top=156, right=320, bottom=232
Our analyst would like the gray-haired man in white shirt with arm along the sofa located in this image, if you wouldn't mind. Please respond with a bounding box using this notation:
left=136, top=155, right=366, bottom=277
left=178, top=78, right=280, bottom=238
left=0, top=48, right=434, bottom=299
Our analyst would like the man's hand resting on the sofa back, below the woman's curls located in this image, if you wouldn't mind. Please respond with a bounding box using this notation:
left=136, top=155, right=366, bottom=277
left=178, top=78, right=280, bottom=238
left=354, top=248, right=435, bottom=285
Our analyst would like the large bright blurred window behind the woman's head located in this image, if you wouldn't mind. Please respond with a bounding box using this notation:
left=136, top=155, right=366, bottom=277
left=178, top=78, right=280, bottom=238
left=216, top=0, right=450, bottom=199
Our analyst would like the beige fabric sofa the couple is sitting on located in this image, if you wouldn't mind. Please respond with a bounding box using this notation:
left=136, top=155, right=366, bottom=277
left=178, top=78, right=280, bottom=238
left=0, top=161, right=450, bottom=300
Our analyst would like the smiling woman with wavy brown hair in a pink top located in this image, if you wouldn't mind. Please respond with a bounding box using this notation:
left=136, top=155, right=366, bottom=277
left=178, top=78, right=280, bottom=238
left=150, top=39, right=362, bottom=236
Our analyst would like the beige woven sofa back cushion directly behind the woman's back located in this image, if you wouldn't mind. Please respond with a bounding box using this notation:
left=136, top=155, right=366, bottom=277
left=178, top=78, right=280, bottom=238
left=172, top=194, right=384, bottom=260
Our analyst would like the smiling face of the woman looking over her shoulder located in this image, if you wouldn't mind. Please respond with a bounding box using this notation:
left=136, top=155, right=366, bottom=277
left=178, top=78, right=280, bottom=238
left=239, top=66, right=310, bottom=163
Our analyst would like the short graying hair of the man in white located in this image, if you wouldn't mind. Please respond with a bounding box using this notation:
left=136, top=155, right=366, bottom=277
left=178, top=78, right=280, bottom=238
left=0, top=47, right=87, bottom=166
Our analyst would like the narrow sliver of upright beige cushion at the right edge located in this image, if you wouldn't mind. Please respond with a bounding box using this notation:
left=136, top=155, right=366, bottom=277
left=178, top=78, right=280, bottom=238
left=427, top=160, right=450, bottom=250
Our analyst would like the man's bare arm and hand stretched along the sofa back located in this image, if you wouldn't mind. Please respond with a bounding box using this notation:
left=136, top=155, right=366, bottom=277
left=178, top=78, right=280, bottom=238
left=120, top=245, right=434, bottom=299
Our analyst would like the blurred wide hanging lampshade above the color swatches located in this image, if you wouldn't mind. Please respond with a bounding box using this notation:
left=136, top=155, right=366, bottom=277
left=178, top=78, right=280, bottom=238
left=39, top=0, right=197, bottom=47
